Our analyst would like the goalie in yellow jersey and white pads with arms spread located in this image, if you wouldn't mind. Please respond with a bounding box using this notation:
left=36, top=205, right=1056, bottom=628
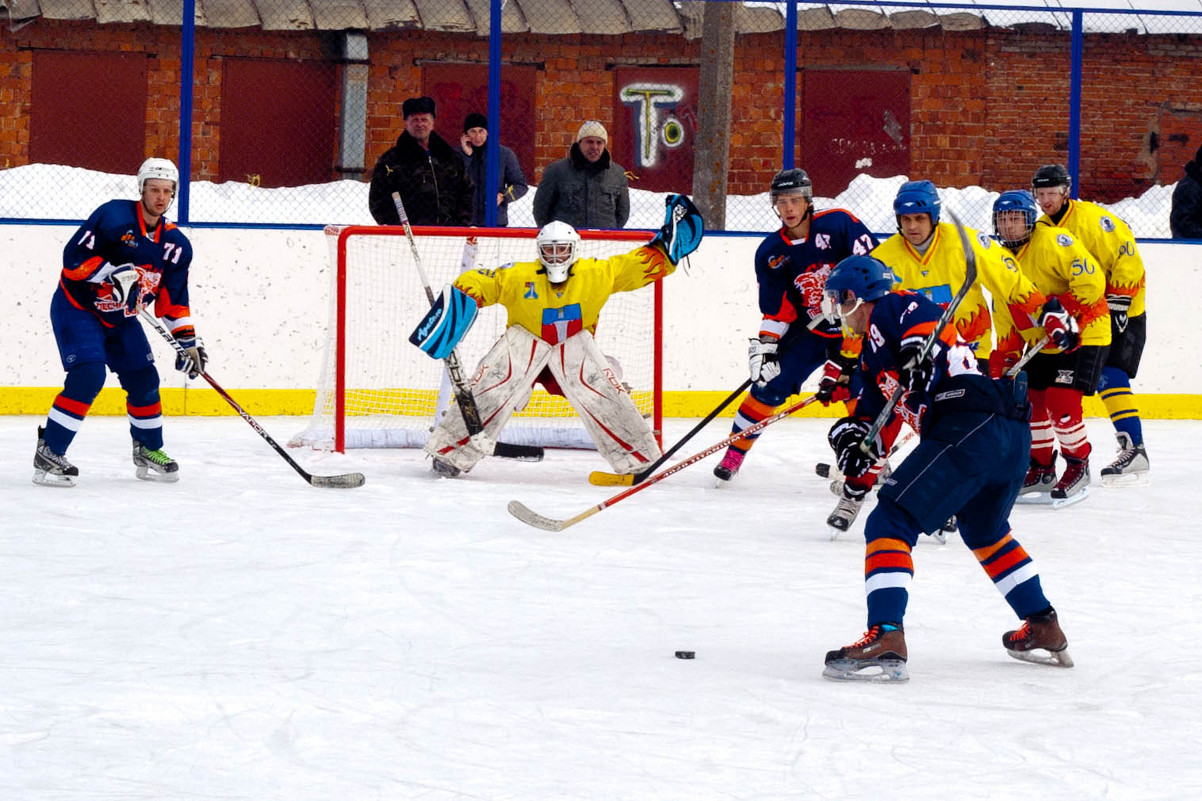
left=412, top=195, right=703, bottom=477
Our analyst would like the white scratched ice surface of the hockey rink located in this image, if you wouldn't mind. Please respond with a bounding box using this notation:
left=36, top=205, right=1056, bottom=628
left=0, top=408, right=1202, bottom=801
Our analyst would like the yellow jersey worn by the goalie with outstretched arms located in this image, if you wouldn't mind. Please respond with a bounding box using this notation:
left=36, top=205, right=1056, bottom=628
left=454, top=245, right=676, bottom=345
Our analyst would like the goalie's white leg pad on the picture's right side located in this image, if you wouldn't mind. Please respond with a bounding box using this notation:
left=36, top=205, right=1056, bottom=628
left=548, top=331, right=660, bottom=475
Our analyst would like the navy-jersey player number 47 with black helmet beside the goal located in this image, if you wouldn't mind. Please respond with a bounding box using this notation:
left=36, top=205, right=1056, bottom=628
left=714, top=170, right=876, bottom=481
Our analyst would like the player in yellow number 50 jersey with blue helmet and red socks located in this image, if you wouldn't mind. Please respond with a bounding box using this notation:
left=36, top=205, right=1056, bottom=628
left=993, top=190, right=1111, bottom=503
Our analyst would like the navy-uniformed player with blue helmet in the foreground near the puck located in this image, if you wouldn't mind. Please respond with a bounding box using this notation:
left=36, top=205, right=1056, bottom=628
left=823, top=256, right=1072, bottom=681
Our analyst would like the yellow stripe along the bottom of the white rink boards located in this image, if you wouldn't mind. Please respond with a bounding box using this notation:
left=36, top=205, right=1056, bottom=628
left=0, top=386, right=1202, bottom=420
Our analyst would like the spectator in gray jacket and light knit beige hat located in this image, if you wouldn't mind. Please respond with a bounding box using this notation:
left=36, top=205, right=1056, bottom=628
left=534, top=120, right=630, bottom=229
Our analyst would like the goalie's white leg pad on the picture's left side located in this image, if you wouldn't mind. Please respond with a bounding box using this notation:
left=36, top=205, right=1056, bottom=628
left=426, top=326, right=552, bottom=473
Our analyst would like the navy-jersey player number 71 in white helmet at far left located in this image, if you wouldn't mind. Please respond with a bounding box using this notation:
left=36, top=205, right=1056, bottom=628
left=34, top=153, right=207, bottom=487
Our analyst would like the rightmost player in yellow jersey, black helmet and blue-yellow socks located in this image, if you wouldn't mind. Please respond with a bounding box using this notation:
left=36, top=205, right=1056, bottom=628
left=1031, top=164, right=1149, bottom=486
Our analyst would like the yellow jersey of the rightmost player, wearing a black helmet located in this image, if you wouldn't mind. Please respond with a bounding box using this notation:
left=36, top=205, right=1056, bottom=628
left=1040, top=200, right=1144, bottom=318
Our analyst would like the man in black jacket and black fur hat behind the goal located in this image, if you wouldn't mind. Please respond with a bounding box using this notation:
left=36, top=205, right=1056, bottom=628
left=368, top=97, right=472, bottom=226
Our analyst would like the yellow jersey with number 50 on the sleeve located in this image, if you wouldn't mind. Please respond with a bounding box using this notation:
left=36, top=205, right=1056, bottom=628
left=1014, top=219, right=1111, bottom=352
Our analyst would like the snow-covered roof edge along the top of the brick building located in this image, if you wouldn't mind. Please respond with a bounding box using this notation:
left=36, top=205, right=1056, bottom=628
left=0, top=0, right=1202, bottom=38
